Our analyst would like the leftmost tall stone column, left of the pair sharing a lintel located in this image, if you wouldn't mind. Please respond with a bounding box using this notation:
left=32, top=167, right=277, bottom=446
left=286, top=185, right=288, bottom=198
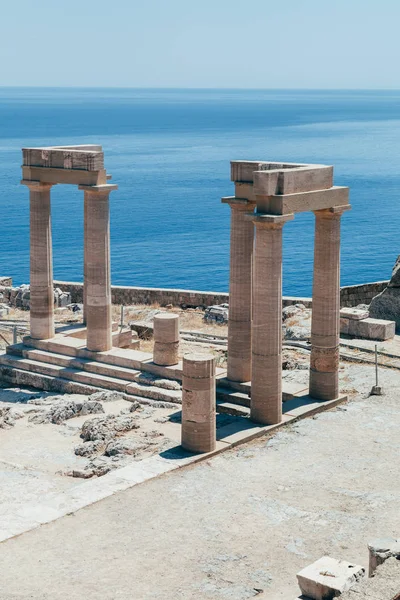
left=21, top=180, right=54, bottom=340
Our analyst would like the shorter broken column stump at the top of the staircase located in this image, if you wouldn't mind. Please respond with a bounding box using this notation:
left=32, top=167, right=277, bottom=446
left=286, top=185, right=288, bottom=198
left=153, top=313, right=179, bottom=367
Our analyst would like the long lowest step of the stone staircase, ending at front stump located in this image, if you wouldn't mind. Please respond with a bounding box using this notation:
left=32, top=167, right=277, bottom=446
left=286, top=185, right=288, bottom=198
left=0, top=354, right=182, bottom=404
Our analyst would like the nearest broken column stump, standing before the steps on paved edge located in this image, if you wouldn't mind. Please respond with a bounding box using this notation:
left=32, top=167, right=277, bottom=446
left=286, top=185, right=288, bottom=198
left=182, top=354, right=216, bottom=452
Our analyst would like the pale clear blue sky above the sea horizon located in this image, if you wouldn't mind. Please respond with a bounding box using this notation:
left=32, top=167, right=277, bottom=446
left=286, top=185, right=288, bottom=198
left=0, top=0, right=400, bottom=88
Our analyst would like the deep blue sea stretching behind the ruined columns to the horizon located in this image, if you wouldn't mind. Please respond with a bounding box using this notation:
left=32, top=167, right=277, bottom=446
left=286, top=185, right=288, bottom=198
left=0, top=88, right=400, bottom=295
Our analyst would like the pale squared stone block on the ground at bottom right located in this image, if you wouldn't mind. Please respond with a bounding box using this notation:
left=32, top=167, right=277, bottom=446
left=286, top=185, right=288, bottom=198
left=297, top=556, right=365, bottom=600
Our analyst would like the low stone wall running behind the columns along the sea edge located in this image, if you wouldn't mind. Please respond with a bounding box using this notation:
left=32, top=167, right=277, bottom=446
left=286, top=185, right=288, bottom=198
left=54, top=281, right=388, bottom=308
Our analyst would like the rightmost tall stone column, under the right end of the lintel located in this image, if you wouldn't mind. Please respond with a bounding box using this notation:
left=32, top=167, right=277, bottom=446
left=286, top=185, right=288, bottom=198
left=310, top=207, right=350, bottom=400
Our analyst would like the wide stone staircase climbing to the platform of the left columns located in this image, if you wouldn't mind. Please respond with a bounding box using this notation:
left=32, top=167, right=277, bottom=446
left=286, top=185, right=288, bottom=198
left=0, top=331, right=308, bottom=417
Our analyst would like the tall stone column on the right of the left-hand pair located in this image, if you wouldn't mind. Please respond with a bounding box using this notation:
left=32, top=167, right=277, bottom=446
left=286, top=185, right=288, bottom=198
left=79, top=184, right=117, bottom=352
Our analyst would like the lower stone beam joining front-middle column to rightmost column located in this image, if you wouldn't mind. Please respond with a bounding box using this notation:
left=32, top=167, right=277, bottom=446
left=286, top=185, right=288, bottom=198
left=256, top=186, right=350, bottom=215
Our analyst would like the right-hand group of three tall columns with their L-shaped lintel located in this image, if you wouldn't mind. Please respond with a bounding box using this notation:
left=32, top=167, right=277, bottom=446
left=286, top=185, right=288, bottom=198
left=222, top=161, right=350, bottom=424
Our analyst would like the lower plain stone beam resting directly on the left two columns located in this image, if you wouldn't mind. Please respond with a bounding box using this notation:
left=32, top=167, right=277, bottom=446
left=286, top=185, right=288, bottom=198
left=22, top=165, right=107, bottom=185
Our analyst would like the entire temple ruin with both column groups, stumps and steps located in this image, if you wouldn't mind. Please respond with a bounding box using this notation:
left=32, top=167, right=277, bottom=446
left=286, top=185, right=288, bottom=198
left=0, top=146, right=356, bottom=452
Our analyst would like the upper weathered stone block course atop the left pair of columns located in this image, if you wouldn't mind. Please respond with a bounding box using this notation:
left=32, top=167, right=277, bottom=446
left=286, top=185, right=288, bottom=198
left=22, top=145, right=104, bottom=171
